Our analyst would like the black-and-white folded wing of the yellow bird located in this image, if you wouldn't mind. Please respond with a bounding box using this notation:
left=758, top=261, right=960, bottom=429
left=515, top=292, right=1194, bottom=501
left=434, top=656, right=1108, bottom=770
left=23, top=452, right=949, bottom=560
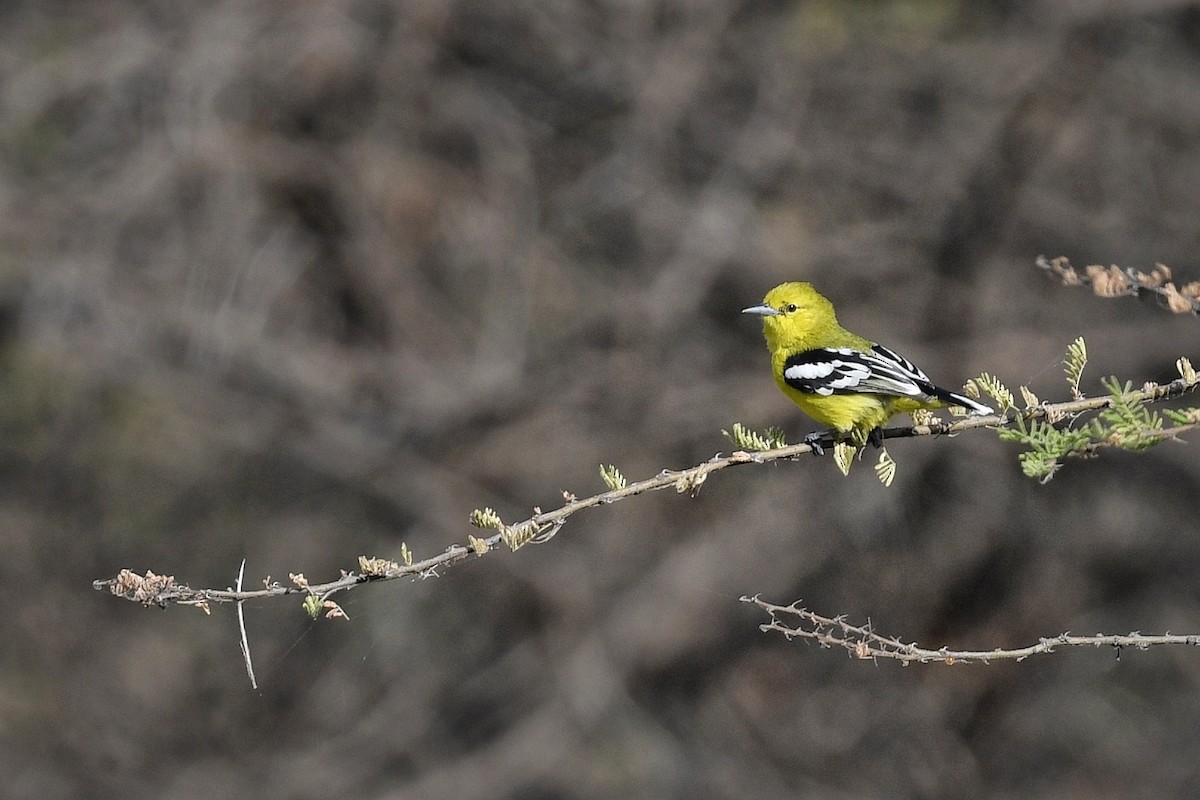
left=784, top=344, right=934, bottom=397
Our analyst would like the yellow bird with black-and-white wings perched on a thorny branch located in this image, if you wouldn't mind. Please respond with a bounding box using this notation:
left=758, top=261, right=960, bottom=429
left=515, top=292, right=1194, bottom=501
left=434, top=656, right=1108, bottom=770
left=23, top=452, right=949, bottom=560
left=742, top=281, right=992, bottom=456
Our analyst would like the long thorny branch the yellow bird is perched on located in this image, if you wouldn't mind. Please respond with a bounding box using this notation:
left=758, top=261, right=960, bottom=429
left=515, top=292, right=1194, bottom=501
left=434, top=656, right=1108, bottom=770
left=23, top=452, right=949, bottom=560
left=92, top=378, right=1198, bottom=609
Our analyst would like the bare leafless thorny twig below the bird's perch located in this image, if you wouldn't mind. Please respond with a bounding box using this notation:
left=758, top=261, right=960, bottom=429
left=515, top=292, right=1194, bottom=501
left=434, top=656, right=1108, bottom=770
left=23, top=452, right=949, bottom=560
left=742, top=595, right=1200, bottom=664
